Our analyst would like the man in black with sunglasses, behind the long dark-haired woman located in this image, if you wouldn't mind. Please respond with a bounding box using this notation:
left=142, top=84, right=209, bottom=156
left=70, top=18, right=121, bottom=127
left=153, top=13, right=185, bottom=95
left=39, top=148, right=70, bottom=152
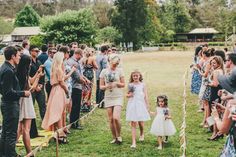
left=29, top=45, right=46, bottom=138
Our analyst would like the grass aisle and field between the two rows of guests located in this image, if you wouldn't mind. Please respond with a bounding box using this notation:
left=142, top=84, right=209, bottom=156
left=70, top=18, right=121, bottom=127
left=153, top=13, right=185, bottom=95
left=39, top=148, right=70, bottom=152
left=0, top=51, right=225, bottom=157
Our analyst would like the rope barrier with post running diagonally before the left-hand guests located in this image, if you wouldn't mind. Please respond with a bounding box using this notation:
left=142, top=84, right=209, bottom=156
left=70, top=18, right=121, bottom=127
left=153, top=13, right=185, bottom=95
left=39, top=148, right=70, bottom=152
left=25, top=99, right=104, bottom=157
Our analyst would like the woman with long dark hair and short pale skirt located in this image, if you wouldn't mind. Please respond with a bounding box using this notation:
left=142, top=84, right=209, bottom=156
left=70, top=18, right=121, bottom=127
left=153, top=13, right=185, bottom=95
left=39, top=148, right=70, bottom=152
left=16, top=55, right=44, bottom=154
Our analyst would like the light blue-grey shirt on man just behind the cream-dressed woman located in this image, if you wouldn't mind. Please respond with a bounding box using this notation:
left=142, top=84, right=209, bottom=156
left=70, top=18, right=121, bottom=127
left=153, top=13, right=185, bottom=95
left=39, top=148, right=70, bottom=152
left=96, top=53, right=108, bottom=80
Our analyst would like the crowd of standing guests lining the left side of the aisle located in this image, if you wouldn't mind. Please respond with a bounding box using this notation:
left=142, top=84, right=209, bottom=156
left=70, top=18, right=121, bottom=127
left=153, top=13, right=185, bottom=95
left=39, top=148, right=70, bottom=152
left=0, top=41, right=113, bottom=157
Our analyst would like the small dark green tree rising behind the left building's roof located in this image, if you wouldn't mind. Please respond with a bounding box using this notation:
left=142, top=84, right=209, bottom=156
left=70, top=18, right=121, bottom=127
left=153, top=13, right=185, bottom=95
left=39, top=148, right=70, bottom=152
left=14, top=4, right=40, bottom=27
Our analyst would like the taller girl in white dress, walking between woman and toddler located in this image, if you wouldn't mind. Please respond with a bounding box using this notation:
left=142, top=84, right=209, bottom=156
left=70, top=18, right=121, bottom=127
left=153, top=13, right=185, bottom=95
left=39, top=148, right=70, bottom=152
left=126, top=70, right=150, bottom=148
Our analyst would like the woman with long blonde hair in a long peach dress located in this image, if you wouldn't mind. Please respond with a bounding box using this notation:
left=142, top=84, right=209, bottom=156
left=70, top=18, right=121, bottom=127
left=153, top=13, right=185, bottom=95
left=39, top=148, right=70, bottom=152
left=42, top=52, right=68, bottom=143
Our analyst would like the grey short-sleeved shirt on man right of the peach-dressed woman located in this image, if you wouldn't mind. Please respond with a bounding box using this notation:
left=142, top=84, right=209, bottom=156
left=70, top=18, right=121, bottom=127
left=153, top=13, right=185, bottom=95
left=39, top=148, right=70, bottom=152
left=66, top=56, right=82, bottom=90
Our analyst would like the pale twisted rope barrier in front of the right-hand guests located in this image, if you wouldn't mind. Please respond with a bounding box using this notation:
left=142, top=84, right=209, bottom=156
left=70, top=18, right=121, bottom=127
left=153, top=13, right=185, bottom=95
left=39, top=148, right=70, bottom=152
left=179, top=69, right=188, bottom=157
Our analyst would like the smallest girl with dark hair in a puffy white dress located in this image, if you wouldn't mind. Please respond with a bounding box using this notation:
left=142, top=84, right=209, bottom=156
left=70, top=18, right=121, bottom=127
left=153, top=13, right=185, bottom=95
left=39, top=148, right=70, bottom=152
left=150, top=95, right=176, bottom=149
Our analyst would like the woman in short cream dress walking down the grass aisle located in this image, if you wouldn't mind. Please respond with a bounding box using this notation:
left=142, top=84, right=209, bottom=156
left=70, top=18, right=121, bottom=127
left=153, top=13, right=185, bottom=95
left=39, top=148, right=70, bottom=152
left=100, top=54, right=125, bottom=144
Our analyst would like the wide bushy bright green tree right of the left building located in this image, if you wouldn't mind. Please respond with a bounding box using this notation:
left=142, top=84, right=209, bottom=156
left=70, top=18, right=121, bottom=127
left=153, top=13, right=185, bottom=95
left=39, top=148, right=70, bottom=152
left=40, top=9, right=98, bottom=44
